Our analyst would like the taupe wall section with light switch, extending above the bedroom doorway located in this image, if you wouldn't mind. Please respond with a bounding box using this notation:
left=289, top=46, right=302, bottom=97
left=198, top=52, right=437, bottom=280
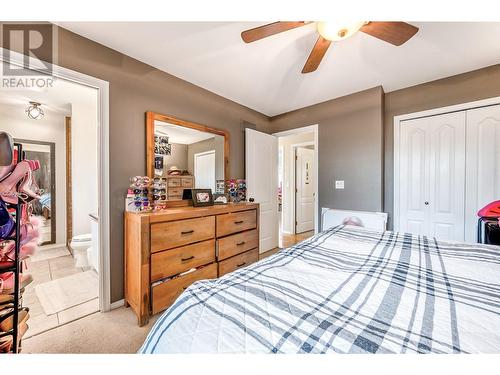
left=271, top=87, right=384, bottom=226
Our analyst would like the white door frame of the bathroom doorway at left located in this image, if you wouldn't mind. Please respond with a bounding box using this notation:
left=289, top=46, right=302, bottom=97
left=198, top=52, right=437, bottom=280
left=0, top=48, right=112, bottom=312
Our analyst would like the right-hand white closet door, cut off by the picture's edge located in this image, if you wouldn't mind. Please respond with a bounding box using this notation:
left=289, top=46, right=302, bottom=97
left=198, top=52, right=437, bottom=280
left=465, top=105, right=500, bottom=242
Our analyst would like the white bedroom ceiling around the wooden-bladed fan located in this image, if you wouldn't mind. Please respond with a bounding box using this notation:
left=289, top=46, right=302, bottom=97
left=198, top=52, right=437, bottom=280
left=58, top=22, right=500, bottom=116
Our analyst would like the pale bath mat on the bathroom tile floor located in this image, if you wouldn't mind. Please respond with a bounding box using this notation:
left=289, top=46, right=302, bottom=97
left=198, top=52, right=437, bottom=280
left=35, top=271, right=99, bottom=315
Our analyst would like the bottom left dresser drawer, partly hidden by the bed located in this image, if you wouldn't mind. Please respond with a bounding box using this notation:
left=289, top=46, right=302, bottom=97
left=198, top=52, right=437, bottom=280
left=151, top=263, right=217, bottom=314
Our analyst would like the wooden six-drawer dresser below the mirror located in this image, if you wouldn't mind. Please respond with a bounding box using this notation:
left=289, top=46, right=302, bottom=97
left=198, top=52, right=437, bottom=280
left=125, top=203, right=259, bottom=326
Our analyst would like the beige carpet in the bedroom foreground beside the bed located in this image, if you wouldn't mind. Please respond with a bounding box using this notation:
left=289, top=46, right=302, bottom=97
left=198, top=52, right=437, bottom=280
left=22, top=307, right=159, bottom=353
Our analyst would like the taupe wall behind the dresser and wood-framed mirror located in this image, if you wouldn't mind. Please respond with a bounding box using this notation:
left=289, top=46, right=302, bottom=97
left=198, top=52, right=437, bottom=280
left=53, top=29, right=269, bottom=301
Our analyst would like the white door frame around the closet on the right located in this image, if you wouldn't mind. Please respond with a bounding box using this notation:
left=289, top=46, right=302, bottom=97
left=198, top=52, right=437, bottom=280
left=393, top=96, right=500, bottom=232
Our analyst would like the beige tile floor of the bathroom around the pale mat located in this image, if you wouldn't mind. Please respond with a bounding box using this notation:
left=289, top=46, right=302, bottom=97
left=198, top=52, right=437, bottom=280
left=23, top=246, right=99, bottom=338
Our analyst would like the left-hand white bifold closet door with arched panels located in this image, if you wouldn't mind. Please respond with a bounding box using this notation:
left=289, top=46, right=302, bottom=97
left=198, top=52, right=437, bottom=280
left=399, top=112, right=466, bottom=241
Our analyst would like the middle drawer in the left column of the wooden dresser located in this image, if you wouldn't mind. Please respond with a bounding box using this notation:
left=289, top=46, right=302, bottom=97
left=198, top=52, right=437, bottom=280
left=151, top=240, right=215, bottom=282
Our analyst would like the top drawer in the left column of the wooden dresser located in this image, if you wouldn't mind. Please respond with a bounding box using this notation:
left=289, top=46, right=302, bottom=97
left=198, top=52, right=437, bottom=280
left=151, top=216, right=215, bottom=253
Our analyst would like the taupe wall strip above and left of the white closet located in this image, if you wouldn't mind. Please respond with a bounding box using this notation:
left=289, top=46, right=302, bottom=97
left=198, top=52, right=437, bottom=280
left=384, top=65, right=500, bottom=228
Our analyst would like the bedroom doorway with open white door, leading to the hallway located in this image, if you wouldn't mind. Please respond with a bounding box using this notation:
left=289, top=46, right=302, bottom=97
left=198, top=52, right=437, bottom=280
left=245, top=125, right=319, bottom=256
